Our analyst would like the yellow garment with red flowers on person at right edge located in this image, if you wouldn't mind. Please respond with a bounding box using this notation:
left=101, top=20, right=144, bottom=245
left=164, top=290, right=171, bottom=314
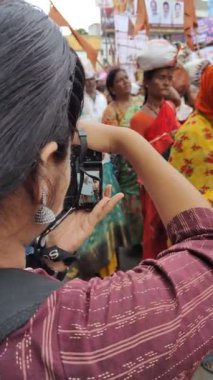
left=169, top=112, right=213, bottom=205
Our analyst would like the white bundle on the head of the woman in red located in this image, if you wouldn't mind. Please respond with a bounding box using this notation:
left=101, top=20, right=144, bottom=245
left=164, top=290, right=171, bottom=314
left=137, top=39, right=178, bottom=71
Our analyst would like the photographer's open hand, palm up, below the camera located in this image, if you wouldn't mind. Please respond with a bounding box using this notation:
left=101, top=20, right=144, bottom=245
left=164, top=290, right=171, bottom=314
left=47, top=185, right=124, bottom=252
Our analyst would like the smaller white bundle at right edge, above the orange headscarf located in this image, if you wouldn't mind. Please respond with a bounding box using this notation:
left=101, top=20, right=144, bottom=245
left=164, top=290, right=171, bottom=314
left=184, top=58, right=211, bottom=86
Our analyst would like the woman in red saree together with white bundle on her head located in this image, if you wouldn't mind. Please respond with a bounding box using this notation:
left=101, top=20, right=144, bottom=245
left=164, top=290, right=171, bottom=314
left=130, top=40, right=179, bottom=258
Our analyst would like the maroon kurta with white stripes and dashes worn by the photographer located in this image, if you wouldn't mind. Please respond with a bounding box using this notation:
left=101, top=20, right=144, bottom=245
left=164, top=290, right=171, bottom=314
left=0, top=209, right=213, bottom=380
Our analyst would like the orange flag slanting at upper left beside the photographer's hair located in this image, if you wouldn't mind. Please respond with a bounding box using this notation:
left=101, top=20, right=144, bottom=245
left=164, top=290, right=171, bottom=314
left=49, top=5, right=98, bottom=67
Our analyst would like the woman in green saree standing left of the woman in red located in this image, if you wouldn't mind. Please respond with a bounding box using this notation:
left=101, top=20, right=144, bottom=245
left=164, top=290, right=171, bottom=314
left=68, top=68, right=142, bottom=278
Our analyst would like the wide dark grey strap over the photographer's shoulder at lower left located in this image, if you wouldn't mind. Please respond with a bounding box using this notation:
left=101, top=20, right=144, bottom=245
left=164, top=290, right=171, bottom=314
left=0, top=268, right=63, bottom=342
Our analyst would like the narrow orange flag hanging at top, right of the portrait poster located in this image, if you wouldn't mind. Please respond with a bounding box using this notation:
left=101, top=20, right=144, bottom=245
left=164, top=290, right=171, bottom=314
left=184, top=0, right=198, bottom=49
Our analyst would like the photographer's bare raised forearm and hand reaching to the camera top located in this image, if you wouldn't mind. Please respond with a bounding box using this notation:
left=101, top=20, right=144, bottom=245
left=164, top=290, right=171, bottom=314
left=78, top=122, right=211, bottom=226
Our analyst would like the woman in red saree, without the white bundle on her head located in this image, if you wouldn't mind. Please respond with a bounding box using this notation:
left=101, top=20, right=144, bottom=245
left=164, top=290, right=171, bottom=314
left=130, top=67, right=178, bottom=259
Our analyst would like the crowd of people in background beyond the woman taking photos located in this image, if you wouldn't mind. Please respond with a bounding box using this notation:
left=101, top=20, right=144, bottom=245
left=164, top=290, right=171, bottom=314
left=72, top=40, right=213, bottom=277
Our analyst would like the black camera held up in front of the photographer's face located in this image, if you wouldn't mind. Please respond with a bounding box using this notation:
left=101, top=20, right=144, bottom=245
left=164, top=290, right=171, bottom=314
left=64, top=145, right=103, bottom=211
